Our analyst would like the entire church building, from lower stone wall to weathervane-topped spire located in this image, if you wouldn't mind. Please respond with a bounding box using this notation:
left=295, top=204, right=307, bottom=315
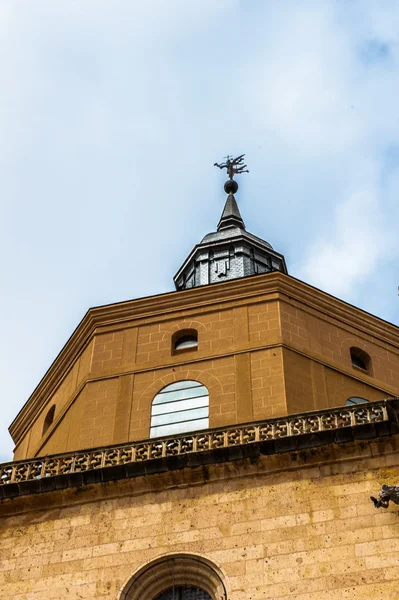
left=0, top=156, right=399, bottom=600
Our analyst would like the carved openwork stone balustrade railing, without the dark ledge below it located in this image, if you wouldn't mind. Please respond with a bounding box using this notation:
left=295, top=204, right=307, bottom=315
left=0, top=401, right=388, bottom=485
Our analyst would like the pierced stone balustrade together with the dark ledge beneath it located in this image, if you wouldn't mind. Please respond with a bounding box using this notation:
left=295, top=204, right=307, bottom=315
left=0, top=398, right=399, bottom=498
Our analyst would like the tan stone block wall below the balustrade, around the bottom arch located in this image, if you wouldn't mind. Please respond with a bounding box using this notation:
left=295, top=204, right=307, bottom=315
left=0, top=439, right=399, bottom=600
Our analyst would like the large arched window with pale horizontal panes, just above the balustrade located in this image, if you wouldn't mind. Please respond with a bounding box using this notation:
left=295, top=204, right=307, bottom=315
left=150, top=381, right=209, bottom=437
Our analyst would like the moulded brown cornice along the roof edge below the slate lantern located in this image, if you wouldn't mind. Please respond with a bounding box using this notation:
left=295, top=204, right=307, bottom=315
left=9, top=272, right=399, bottom=442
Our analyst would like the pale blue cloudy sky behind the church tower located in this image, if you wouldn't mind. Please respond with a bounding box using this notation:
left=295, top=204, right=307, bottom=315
left=0, top=0, right=399, bottom=461
